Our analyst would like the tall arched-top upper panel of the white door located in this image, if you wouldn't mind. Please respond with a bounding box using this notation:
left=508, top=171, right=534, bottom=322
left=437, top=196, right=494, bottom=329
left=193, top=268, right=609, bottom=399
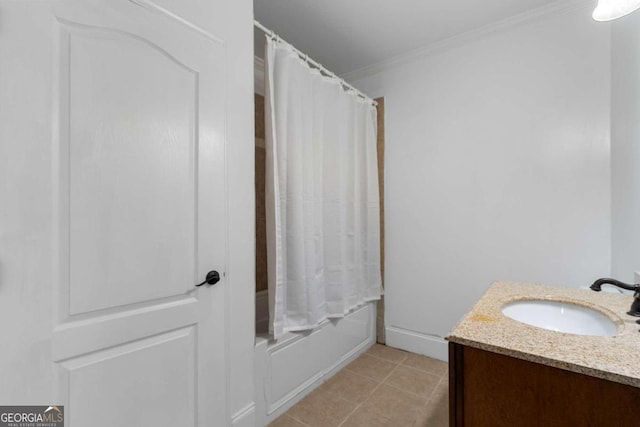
left=67, top=26, right=198, bottom=315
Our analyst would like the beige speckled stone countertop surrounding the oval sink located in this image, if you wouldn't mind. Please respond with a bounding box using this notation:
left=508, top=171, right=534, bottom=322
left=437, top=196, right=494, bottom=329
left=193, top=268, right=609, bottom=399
left=447, top=282, right=640, bottom=387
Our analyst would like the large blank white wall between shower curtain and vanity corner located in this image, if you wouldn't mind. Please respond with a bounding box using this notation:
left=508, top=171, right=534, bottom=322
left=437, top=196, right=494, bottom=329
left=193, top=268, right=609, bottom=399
left=354, top=4, right=608, bottom=358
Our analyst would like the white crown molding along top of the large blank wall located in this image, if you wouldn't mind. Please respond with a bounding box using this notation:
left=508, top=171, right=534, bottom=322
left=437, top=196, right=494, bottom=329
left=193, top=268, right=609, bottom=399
left=341, top=0, right=593, bottom=81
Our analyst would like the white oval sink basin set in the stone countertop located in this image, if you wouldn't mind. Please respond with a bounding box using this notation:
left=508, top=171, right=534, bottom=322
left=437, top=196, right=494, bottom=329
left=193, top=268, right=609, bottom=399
left=502, top=300, right=618, bottom=336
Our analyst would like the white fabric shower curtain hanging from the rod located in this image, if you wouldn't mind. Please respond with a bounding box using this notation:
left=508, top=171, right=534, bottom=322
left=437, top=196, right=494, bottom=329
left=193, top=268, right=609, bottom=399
left=265, top=38, right=381, bottom=339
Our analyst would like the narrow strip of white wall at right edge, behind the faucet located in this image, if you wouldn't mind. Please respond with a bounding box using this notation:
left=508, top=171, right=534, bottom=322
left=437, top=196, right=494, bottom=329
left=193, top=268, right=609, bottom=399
left=611, top=12, right=640, bottom=283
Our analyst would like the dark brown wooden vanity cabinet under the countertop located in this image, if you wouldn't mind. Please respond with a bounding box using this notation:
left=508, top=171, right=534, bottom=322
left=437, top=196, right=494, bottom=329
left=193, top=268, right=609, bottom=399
left=449, top=342, right=640, bottom=427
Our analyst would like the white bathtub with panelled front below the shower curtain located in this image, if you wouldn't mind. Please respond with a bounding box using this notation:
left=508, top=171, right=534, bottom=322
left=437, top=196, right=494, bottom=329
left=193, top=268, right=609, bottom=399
left=254, top=291, right=376, bottom=426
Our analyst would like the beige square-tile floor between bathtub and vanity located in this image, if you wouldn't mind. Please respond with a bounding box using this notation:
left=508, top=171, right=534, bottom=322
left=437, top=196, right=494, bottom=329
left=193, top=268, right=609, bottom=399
left=270, top=344, right=449, bottom=427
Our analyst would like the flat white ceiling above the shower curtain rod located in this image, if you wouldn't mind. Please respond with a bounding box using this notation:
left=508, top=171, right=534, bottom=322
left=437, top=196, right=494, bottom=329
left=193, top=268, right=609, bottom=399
left=253, top=0, right=584, bottom=74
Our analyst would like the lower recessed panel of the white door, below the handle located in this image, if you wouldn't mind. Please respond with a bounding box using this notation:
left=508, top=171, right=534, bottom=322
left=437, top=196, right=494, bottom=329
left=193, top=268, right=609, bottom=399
left=61, top=327, right=197, bottom=427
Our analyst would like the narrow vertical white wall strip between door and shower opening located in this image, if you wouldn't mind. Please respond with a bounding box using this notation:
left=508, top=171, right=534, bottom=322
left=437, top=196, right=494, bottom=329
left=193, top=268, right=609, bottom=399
left=224, top=1, right=256, bottom=427
